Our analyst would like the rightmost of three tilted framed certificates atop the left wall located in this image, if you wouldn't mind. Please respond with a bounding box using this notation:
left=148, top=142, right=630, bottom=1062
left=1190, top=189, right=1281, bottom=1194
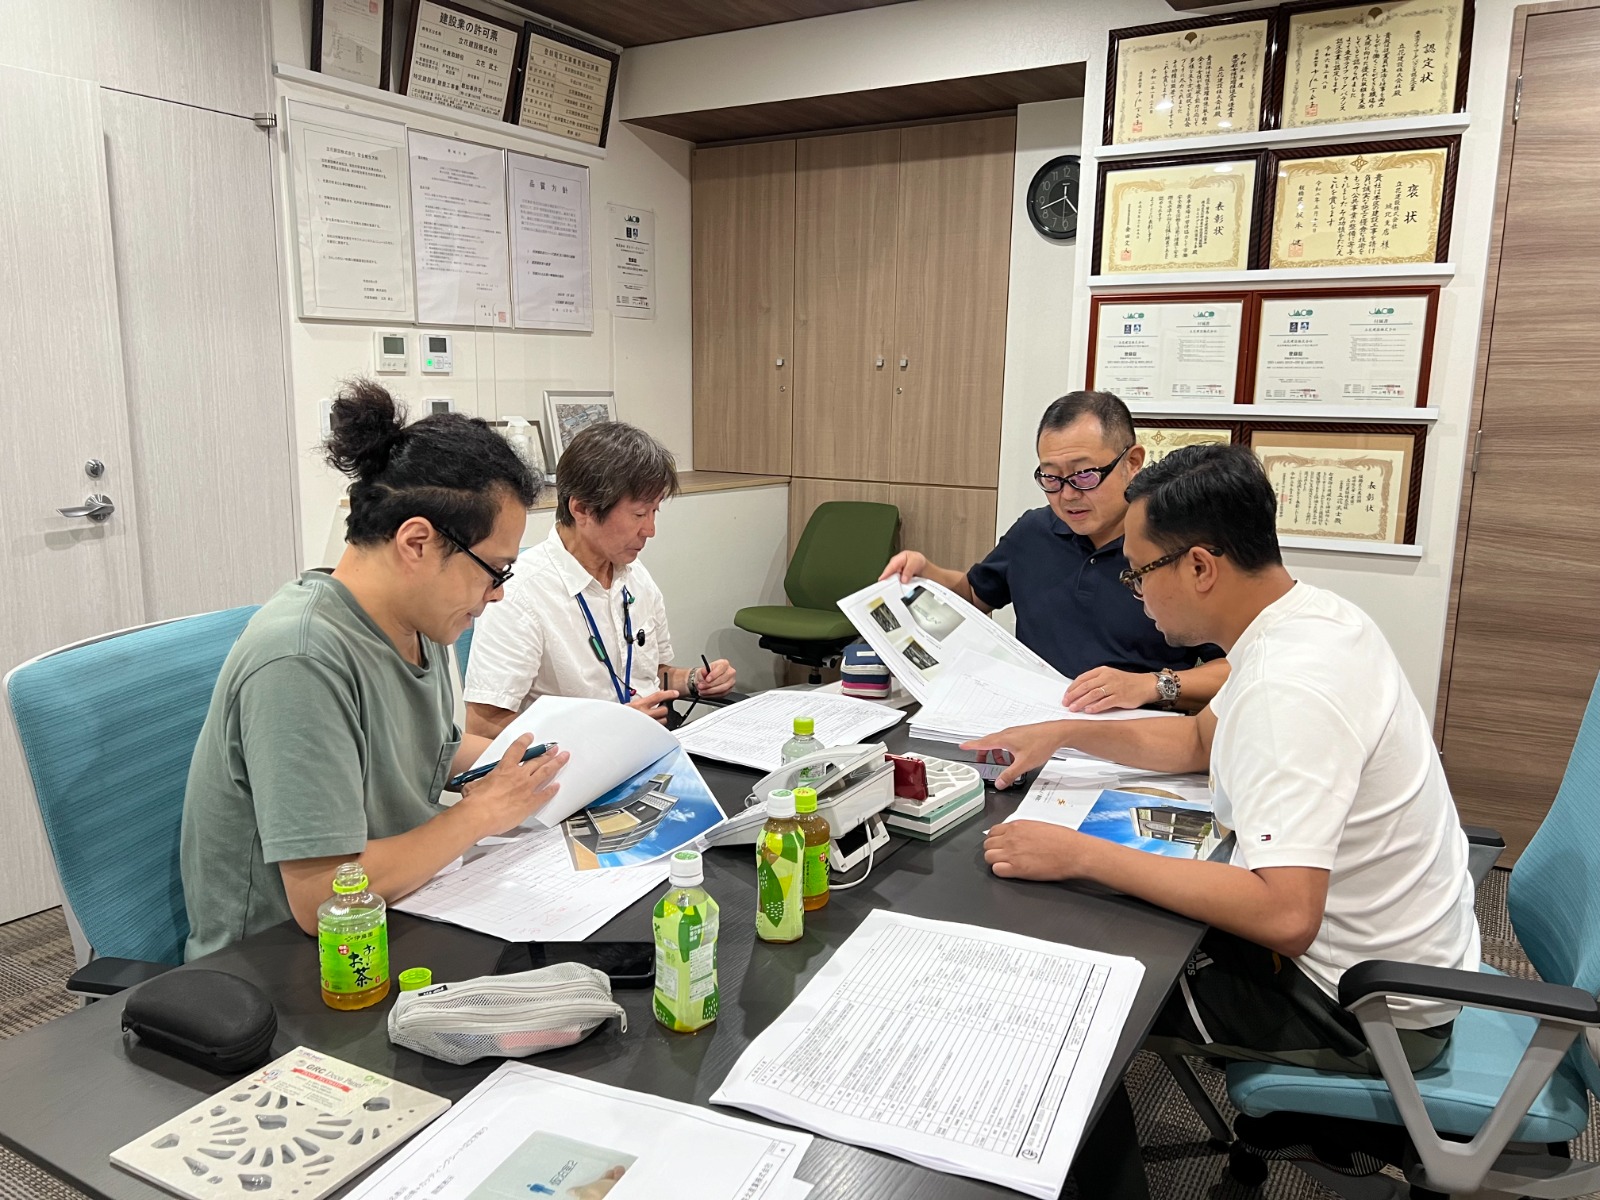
left=510, top=21, right=621, bottom=146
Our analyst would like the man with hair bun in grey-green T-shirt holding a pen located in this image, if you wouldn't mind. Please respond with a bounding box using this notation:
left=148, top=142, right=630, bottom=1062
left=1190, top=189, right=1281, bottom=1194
left=181, top=381, right=566, bottom=958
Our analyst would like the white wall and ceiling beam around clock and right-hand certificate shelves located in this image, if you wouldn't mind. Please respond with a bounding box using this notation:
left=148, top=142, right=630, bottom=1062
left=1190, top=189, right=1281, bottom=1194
left=621, top=0, right=1515, bottom=710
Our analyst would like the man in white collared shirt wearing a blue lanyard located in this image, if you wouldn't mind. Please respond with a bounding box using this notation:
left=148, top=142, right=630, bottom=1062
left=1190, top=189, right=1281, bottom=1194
left=466, top=422, right=734, bottom=736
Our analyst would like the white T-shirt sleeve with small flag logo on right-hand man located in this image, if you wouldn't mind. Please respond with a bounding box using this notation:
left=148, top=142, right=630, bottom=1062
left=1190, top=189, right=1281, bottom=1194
left=1213, top=683, right=1366, bottom=870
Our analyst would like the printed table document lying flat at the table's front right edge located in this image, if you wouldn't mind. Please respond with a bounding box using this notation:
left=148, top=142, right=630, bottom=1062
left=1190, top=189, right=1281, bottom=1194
left=712, top=909, right=1144, bottom=1200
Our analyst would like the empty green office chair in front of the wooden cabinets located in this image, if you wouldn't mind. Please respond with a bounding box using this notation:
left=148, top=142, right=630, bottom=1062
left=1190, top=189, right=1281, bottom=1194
left=733, top=501, right=899, bottom=683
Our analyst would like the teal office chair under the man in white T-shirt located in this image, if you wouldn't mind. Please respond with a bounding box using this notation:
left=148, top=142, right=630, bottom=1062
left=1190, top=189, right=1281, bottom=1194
left=1227, top=672, right=1600, bottom=1198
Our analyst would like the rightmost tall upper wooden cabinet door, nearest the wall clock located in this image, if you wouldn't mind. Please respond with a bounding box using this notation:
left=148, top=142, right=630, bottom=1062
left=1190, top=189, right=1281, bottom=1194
left=891, top=117, right=1016, bottom=489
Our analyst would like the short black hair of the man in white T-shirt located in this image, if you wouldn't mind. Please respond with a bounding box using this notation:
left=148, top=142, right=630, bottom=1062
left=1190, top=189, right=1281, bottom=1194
left=1128, top=445, right=1283, bottom=571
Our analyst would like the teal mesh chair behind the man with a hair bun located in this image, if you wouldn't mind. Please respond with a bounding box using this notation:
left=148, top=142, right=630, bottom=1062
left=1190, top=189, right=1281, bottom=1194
left=5, top=605, right=256, bottom=995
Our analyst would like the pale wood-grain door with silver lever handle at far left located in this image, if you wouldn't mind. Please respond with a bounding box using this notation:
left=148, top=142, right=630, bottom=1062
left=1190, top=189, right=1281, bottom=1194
left=0, top=67, right=148, bottom=923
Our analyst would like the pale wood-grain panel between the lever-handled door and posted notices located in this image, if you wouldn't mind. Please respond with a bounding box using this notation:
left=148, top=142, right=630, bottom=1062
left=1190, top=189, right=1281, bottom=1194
left=102, top=91, right=299, bottom=621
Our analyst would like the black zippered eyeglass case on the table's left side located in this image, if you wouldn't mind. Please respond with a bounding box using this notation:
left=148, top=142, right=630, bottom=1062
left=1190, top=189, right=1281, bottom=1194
left=122, top=970, right=278, bottom=1075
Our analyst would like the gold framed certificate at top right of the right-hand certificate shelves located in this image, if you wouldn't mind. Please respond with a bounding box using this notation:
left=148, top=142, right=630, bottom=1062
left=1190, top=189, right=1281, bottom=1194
left=1278, top=0, right=1472, bottom=130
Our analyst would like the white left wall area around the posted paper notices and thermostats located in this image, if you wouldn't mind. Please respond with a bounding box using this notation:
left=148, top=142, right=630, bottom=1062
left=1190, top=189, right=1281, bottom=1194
left=270, top=0, right=693, bottom=566
